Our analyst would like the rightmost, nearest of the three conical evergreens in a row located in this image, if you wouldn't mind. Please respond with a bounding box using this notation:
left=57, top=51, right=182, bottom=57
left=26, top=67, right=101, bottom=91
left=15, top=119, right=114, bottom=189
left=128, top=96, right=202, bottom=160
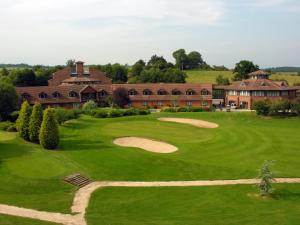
left=39, top=108, right=59, bottom=149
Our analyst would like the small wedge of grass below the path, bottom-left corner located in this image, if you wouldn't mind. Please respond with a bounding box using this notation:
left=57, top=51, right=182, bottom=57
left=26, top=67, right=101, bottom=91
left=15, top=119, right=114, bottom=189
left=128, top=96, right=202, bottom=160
left=0, top=214, right=58, bottom=225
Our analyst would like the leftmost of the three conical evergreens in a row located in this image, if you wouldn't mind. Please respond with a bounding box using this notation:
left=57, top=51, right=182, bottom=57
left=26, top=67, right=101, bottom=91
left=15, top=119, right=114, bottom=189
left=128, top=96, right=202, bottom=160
left=16, top=101, right=31, bottom=141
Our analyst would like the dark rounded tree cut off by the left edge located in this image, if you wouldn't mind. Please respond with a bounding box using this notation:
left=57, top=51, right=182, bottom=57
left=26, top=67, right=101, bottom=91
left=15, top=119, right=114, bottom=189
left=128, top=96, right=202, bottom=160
left=0, top=78, right=18, bottom=121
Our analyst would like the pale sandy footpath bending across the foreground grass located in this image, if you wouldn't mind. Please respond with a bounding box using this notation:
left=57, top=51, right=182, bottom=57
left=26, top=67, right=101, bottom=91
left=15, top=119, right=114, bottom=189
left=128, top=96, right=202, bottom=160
left=0, top=178, right=300, bottom=225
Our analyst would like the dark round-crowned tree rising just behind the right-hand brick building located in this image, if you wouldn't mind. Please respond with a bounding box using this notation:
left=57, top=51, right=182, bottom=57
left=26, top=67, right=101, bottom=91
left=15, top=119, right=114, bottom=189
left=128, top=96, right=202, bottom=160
left=233, top=60, right=259, bottom=80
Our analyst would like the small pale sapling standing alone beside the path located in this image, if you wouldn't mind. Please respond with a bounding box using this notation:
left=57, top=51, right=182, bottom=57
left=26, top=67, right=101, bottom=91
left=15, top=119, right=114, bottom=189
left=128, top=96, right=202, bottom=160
left=257, top=161, right=274, bottom=196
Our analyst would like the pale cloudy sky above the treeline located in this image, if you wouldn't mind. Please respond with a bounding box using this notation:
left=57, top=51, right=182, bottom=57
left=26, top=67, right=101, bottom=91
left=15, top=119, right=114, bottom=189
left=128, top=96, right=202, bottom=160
left=0, top=0, right=300, bottom=68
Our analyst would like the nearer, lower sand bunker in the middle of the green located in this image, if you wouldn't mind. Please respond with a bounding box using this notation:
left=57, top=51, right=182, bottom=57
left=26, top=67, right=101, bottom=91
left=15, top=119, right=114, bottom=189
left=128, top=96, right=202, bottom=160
left=114, top=137, right=178, bottom=153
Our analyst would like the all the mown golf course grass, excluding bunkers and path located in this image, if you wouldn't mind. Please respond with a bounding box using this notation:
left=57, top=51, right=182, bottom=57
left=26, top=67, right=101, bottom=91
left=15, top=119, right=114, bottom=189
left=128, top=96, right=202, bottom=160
left=0, top=112, right=300, bottom=225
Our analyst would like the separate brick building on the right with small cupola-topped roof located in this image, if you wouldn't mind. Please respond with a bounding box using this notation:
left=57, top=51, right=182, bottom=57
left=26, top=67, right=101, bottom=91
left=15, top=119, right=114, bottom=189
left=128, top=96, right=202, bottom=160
left=223, top=70, right=297, bottom=109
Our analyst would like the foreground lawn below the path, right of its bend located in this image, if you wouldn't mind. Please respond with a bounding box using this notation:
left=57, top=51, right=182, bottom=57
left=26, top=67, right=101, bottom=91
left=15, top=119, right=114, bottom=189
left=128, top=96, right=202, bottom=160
left=87, top=184, right=300, bottom=225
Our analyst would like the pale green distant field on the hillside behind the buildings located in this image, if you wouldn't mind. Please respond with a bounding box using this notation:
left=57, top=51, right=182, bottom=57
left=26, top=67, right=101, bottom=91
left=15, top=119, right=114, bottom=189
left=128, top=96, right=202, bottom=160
left=186, top=70, right=300, bottom=85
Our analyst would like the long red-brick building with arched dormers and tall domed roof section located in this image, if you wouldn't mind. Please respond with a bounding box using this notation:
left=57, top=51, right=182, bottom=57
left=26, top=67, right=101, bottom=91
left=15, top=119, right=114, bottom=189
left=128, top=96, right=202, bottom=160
left=17, top=61, right=213, bottom=108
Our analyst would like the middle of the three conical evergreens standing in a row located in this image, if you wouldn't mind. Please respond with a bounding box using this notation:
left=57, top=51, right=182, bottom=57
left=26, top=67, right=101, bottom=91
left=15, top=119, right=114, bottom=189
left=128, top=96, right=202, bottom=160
left=29, top=103, right=43, bottom=143
